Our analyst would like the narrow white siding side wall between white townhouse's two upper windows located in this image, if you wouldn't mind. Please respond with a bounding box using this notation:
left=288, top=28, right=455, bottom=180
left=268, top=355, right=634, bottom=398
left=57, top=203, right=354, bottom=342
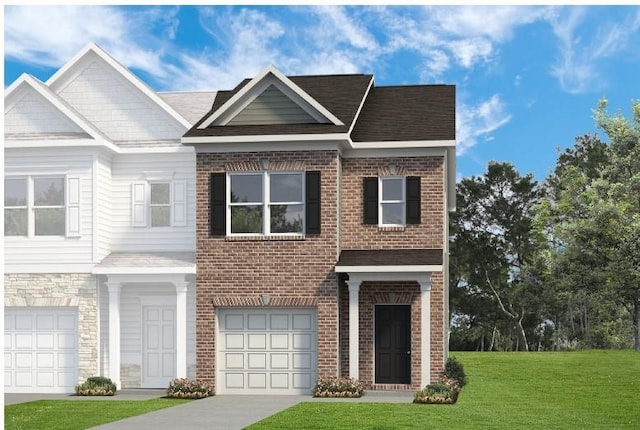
left=96, top=156, right=113, bottom=262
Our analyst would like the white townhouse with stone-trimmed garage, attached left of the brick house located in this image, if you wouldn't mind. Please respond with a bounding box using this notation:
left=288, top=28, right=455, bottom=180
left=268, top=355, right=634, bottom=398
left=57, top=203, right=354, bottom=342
left=4, top=44, right=215, bottom=392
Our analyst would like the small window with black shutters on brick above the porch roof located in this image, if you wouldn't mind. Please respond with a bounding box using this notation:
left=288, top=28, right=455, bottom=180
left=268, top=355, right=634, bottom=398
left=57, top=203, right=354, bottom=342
left=362, top=176, right=421, bottom=226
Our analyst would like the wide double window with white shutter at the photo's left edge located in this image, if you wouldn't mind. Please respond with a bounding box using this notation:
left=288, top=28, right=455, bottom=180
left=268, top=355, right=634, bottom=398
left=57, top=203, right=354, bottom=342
left=4, top=176, right=74, bottom=237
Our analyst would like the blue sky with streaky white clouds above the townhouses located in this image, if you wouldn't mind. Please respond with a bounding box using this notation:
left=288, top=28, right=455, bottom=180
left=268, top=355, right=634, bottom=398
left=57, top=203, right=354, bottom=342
left=4, top=5, right=640, bottom=180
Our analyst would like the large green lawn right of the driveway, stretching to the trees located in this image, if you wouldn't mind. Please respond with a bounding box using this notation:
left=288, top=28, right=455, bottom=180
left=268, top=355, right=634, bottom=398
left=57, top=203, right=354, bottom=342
left=249, top=351, right=640, bottom=430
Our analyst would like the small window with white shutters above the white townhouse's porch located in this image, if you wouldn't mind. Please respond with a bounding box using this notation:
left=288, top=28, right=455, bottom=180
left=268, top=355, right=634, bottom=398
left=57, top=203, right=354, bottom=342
left=131, top=180, right=187, bottom=227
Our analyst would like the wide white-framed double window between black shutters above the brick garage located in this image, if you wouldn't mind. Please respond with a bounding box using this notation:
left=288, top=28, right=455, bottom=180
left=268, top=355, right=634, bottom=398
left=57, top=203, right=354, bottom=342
left=227, top=171, right=305, bottom=235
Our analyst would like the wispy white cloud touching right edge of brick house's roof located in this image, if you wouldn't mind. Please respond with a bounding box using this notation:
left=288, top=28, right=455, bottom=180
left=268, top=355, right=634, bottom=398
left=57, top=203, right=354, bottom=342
left=456, top=94, right=511, bottom=155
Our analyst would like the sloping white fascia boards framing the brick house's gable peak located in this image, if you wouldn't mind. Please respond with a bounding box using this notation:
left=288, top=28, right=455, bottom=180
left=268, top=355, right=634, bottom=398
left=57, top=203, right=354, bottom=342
left=198, top=65, right=344, bottom=129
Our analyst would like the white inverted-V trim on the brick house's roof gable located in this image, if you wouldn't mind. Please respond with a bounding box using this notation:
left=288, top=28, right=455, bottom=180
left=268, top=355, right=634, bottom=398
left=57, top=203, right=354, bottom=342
left=198, top=65, right=344, bottom=129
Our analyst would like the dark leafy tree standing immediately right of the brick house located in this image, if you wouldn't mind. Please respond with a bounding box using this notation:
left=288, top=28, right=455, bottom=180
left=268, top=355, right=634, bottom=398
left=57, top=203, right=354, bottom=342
left=451, top=162, right=542, bottom=350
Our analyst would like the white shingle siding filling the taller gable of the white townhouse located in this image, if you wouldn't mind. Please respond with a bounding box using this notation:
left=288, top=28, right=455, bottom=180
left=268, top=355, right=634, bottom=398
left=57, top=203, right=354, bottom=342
left=58, top=57, right=186, bottom=141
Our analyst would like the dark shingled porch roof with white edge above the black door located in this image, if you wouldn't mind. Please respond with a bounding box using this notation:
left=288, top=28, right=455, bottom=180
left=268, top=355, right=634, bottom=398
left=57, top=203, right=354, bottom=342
left=335, top=249, right=443, bottom=273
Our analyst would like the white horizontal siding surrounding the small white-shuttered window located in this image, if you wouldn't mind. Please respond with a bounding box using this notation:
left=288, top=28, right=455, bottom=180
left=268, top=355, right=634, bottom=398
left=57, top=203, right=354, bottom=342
left=111, top=153, right=196, bottom=252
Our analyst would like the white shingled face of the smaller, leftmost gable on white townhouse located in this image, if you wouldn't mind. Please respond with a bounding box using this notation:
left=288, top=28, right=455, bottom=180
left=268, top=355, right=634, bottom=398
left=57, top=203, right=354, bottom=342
left=4, top=88, right=86, bottom=136
